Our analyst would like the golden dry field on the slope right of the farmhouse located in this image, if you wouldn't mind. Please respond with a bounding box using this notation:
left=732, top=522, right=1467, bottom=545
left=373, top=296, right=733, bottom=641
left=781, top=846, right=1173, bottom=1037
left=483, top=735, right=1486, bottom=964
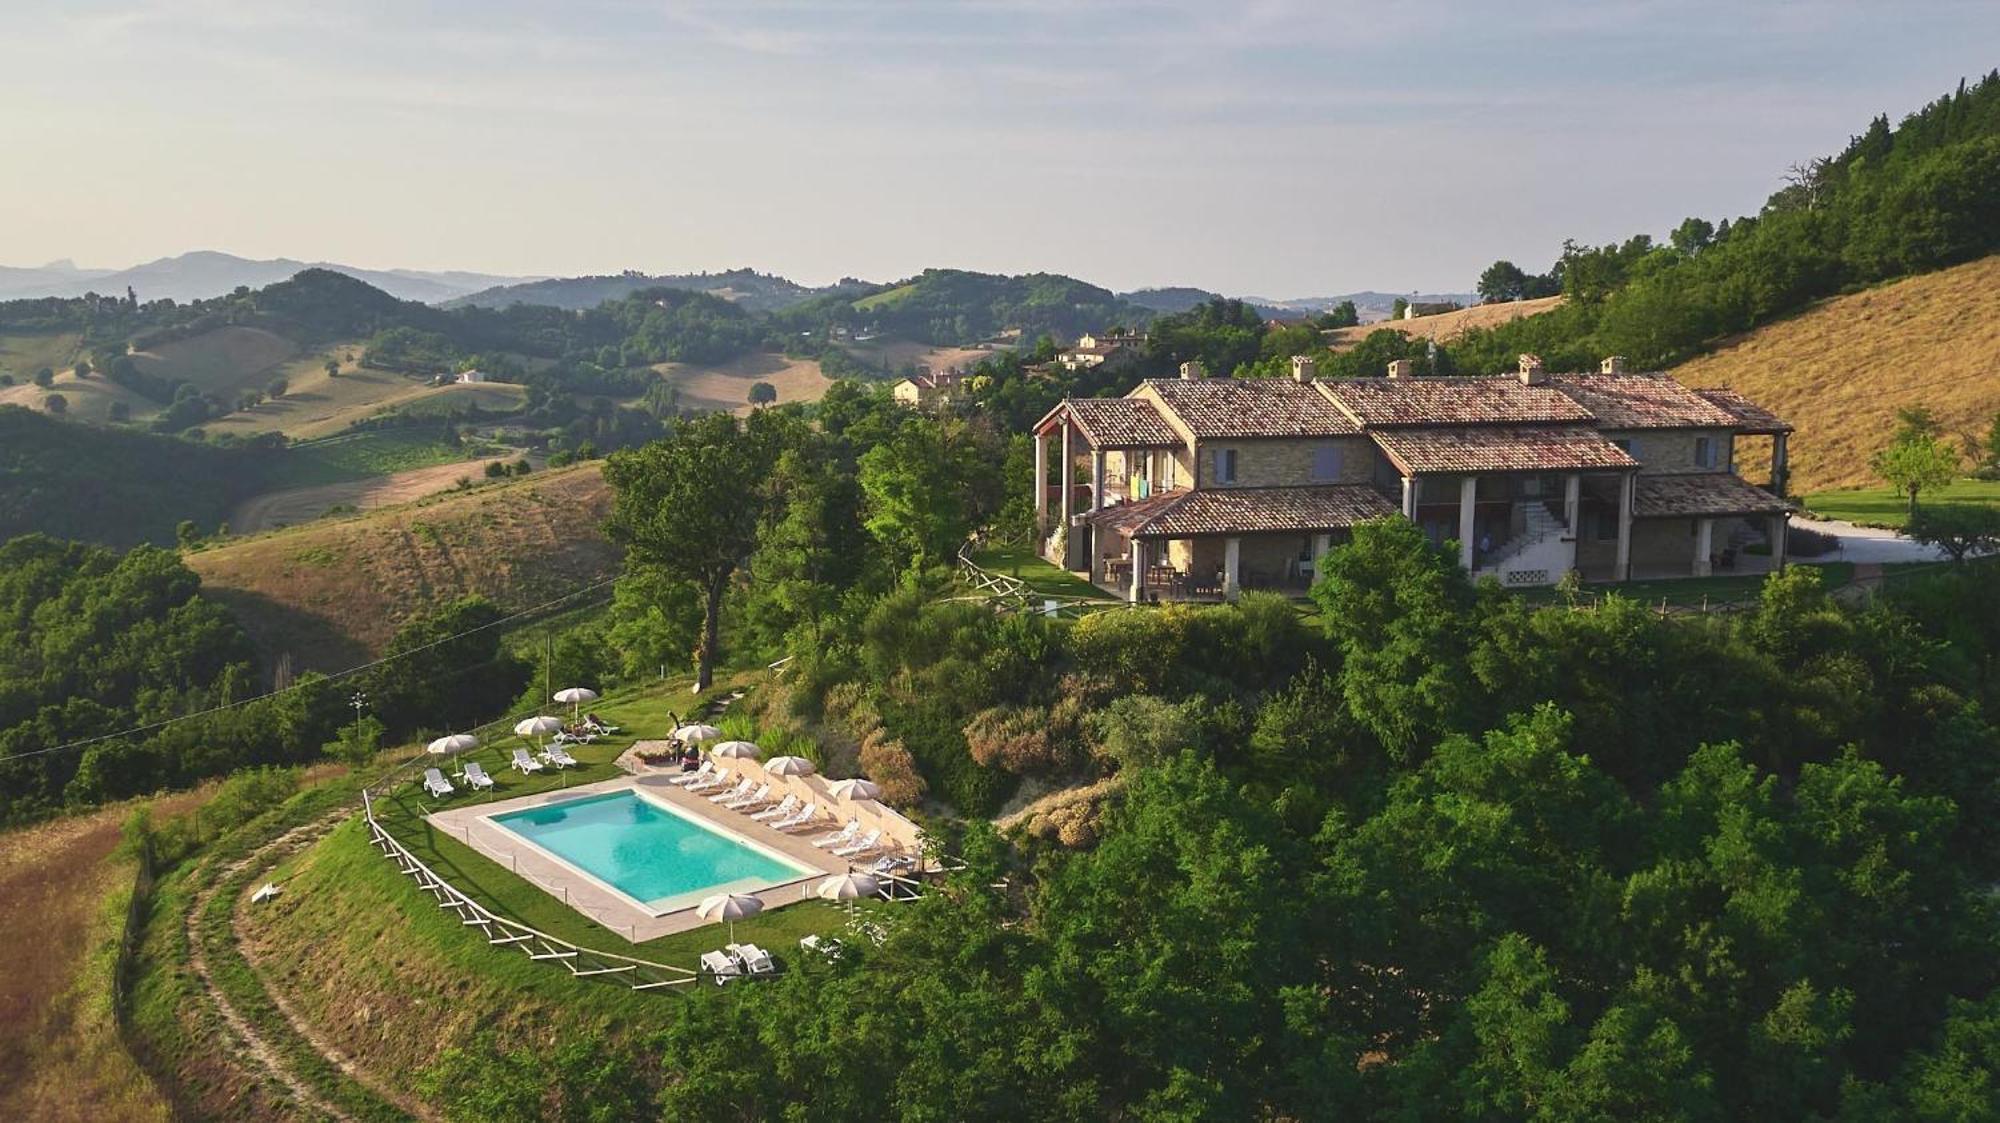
left=1674, top=256, right=2000, bottom=494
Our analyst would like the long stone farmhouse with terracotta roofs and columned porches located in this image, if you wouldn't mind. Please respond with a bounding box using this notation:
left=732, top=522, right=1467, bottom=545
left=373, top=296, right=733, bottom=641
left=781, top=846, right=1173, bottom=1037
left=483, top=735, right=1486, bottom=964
left=1034, top=356, right=1792, bottom=599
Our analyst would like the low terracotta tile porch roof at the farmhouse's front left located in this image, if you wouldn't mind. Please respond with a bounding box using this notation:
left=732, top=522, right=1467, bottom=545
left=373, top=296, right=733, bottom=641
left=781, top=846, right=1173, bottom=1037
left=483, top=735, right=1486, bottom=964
left=1090, top=484, right=1396, bottom=538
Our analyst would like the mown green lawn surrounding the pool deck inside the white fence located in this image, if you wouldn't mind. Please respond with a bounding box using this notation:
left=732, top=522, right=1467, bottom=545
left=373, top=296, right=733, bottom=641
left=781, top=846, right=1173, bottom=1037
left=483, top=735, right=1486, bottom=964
left=362, top=679, right=896, bottom=969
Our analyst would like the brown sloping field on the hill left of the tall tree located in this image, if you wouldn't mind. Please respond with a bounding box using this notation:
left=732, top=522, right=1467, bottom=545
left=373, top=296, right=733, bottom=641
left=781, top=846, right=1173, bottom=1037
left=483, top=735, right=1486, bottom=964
left=188, top=464, right=618, bottom=669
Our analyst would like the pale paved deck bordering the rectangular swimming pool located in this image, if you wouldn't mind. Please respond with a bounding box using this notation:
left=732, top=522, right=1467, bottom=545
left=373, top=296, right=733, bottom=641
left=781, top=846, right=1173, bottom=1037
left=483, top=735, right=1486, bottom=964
left=426, top=773, right=852, bottom=943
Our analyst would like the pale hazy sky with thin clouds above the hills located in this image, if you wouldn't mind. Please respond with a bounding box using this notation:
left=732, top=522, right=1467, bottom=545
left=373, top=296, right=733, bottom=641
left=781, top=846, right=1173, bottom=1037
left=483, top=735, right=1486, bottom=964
left=0, top=0, right=2000, bottom=298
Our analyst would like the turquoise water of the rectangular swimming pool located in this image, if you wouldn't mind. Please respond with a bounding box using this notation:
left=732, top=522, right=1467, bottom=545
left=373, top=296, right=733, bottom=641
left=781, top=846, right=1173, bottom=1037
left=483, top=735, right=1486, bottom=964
left=494, top=791, right=814, bottom=911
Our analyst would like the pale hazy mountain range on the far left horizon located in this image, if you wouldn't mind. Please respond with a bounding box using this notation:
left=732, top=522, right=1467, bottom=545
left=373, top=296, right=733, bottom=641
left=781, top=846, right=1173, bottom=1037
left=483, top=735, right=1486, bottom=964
left=0, top=250, right=538, bottom=304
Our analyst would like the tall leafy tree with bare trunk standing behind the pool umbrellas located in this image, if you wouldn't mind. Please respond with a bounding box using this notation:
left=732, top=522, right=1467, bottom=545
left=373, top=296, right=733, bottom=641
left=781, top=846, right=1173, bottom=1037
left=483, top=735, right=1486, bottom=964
left=604, top=414, right=772, bottom=689
